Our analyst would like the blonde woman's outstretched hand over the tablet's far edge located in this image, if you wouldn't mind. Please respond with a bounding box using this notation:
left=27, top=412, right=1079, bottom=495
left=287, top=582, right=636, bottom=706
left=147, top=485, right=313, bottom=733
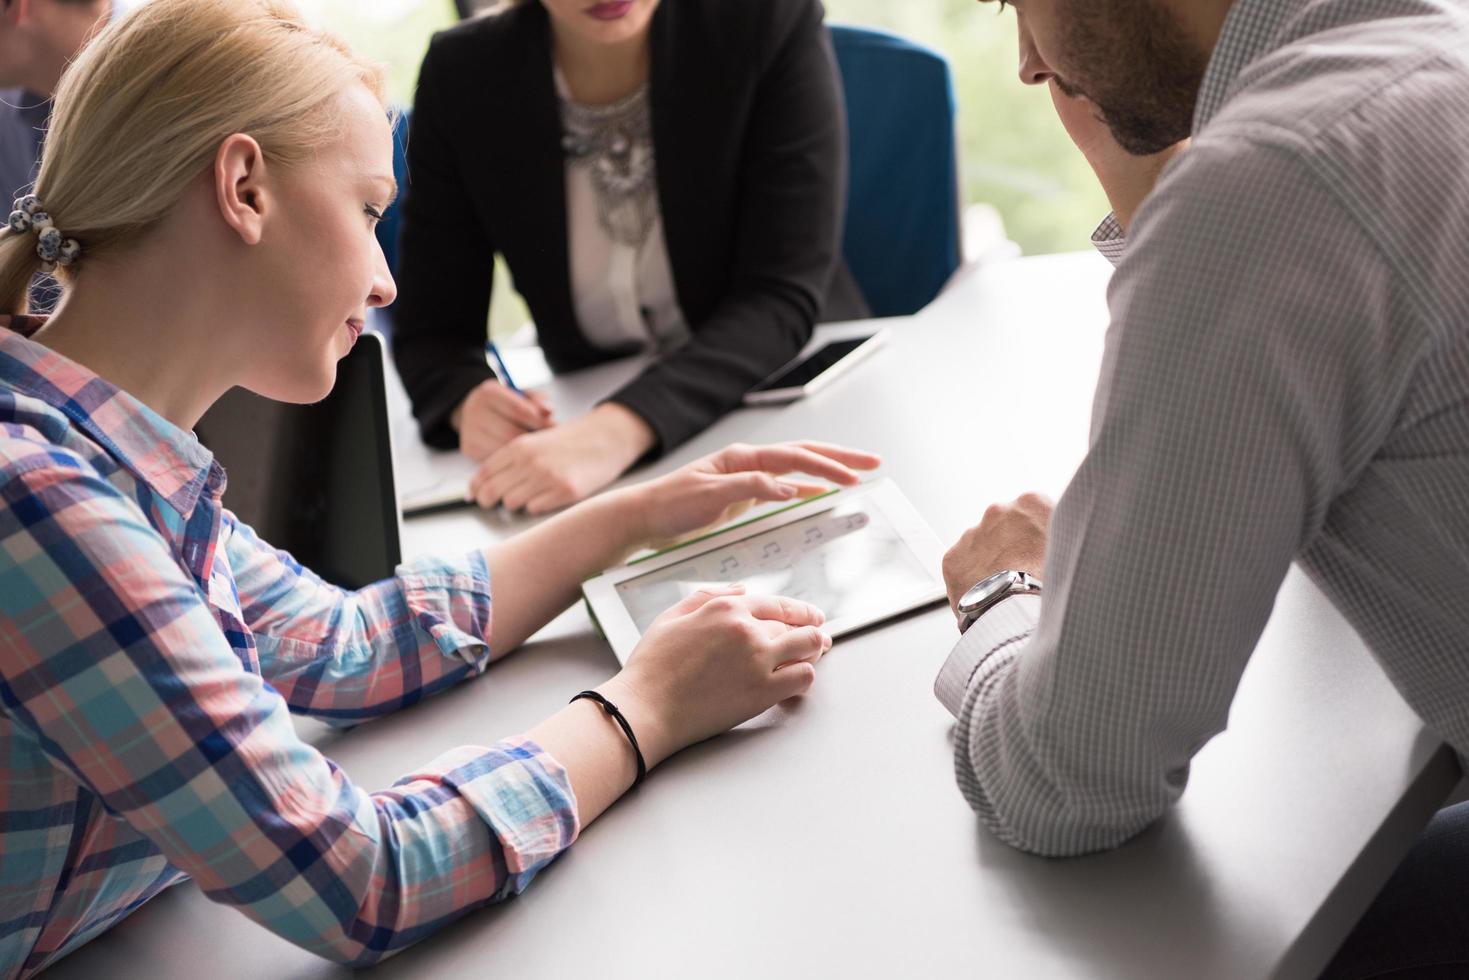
left=627, top=442, right=881, bottom=547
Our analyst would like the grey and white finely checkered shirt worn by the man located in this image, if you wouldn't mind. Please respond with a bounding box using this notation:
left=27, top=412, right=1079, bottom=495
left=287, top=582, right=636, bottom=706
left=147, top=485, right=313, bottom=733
left=937, top=0, right=1469, bottom=855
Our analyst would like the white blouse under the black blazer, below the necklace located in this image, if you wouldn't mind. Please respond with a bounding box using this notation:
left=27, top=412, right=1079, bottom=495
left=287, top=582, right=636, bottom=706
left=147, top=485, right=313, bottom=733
left=555, top=69, right=689, bottom=351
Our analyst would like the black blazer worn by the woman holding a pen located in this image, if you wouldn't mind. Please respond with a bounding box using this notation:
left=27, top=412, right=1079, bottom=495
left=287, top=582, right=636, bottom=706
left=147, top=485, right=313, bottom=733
left=394, top=0, right=865, bottom=450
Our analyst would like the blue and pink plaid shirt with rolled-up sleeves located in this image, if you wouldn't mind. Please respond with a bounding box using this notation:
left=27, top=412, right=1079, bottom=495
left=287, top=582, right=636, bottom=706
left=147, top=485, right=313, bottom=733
left=0, top=317, right=579, bottom=977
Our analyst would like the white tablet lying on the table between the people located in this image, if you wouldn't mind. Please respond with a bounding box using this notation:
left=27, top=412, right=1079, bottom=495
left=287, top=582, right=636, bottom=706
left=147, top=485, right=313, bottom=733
left=582, top=479, right=946, bottom=663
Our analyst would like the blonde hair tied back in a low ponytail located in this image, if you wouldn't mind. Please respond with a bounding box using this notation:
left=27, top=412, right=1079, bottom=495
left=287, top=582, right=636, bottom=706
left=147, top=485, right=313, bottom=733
left=0, top=0, right=385, bottom=313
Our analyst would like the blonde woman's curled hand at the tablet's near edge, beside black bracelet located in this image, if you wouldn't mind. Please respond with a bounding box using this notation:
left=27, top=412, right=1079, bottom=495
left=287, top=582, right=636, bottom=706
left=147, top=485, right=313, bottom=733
left=599, top=588, right=831, bottom=767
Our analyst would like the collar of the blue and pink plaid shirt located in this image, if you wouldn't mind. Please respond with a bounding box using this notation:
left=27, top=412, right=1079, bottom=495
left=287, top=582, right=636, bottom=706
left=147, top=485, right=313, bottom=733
left=0, top=316, right=225, bottom=519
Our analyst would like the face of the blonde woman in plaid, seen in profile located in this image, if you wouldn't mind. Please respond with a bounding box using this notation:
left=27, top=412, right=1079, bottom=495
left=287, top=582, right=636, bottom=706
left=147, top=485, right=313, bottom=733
left=244, top=87, right=397, bottom=404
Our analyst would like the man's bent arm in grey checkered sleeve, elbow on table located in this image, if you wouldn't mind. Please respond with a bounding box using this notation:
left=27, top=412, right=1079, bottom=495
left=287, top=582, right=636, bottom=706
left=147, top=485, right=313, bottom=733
left=946, top=138, right=1401, bottom=855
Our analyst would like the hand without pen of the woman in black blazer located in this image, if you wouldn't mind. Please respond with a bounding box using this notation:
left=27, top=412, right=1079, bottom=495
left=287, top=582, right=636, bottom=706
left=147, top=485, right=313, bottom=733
left=469, top=403, right=655, bottom=514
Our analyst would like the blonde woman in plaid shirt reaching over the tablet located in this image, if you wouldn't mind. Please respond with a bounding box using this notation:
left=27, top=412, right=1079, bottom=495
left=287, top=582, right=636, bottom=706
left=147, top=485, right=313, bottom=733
left=0, top=0, right=876, bottom=977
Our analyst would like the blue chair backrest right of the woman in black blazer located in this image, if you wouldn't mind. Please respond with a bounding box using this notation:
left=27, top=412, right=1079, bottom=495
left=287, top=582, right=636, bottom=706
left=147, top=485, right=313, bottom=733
left=830, top=25, right=962, bottom=316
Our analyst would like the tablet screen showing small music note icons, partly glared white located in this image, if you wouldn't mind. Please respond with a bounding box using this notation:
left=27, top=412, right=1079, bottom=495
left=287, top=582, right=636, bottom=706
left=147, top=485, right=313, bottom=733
left=617, top=498, right=934, bottom=633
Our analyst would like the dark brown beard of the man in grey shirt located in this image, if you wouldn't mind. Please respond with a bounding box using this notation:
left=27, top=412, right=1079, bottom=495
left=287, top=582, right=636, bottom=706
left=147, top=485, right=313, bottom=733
left=1061, top=0, right=1209, bottom=156
